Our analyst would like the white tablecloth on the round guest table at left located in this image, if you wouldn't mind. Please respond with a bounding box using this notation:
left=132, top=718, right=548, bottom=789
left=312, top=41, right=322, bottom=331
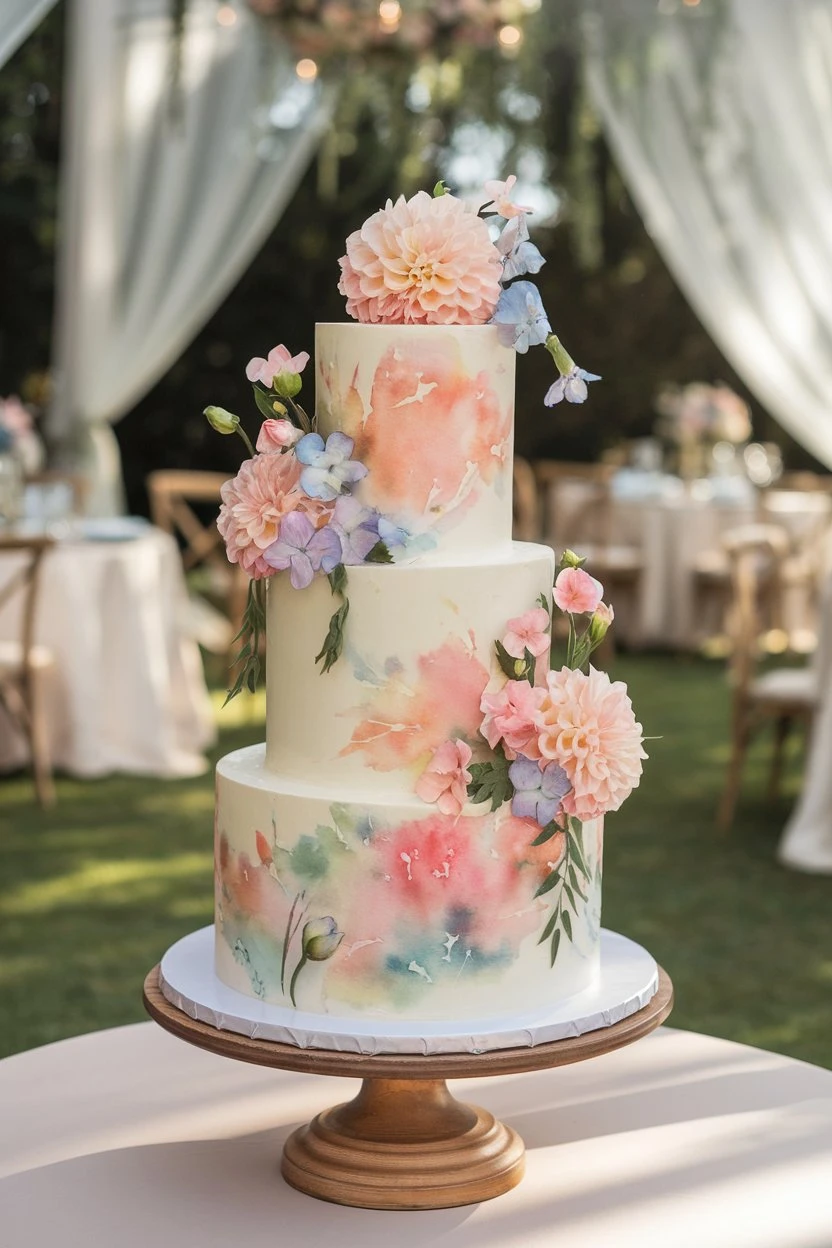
left=0, top=525, right=215, bottom=776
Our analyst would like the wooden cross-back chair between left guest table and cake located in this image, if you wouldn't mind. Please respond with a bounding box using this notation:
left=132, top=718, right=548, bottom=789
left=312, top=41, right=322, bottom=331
left=147, top=468, right=248, bottom=661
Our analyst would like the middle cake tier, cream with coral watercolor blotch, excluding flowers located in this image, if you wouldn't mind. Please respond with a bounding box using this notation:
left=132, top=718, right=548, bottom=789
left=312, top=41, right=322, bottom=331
left=266, top=542, right=555, bottom=791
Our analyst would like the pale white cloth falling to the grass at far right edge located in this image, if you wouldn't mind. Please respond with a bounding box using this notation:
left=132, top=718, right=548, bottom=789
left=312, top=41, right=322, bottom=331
left=777, top=578, right=832, bottom=875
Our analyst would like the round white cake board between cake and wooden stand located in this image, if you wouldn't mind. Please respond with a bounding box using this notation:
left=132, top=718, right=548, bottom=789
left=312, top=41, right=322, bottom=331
left=160, top=926, right=659, bottom=1055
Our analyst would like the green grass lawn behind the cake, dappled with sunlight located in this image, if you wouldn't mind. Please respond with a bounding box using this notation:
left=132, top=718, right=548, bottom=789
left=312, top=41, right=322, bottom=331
left=0, top=656, right=832, bottom=1068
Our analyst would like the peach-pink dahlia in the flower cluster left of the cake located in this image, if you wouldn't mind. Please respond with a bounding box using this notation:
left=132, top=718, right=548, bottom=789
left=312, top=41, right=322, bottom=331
left=217, top=456, right=326, bottom=579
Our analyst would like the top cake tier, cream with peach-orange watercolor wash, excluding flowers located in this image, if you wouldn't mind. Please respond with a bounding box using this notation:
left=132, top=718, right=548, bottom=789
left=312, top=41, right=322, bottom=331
left=314, top=324, right=515, bottom=563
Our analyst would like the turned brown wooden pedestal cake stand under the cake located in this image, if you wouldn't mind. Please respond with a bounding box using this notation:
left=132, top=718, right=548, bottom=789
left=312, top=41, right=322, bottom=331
left=143, top=966, right=674, bottom=1209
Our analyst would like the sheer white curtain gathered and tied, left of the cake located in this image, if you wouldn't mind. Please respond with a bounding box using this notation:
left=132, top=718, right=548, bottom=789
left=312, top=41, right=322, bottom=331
left=50, top=0, right=328, bottom=513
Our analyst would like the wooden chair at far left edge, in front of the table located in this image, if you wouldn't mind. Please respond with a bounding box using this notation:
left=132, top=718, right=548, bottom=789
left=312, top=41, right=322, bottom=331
left=0, top=535, right=55, bottom=806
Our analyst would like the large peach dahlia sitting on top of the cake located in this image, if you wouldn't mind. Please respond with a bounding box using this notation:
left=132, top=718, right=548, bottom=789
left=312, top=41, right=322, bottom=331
left=338, top=191, right=503, bottom=324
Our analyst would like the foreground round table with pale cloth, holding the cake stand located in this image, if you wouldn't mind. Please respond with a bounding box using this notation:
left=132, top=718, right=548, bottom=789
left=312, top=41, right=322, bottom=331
left=0, top=1018, right=832, bottom=1248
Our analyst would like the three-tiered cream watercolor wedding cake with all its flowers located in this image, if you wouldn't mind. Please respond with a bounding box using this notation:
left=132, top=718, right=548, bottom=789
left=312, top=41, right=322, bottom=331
left=207, top=180, right=644, bottom=1035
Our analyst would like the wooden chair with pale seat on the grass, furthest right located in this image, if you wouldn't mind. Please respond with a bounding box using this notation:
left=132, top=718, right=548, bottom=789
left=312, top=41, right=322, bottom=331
left=717, top=524, right=818, bottom=830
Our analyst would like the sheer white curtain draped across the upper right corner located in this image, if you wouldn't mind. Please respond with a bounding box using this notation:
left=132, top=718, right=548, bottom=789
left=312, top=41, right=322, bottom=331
left=586, top=0, right=832, bottom=468
